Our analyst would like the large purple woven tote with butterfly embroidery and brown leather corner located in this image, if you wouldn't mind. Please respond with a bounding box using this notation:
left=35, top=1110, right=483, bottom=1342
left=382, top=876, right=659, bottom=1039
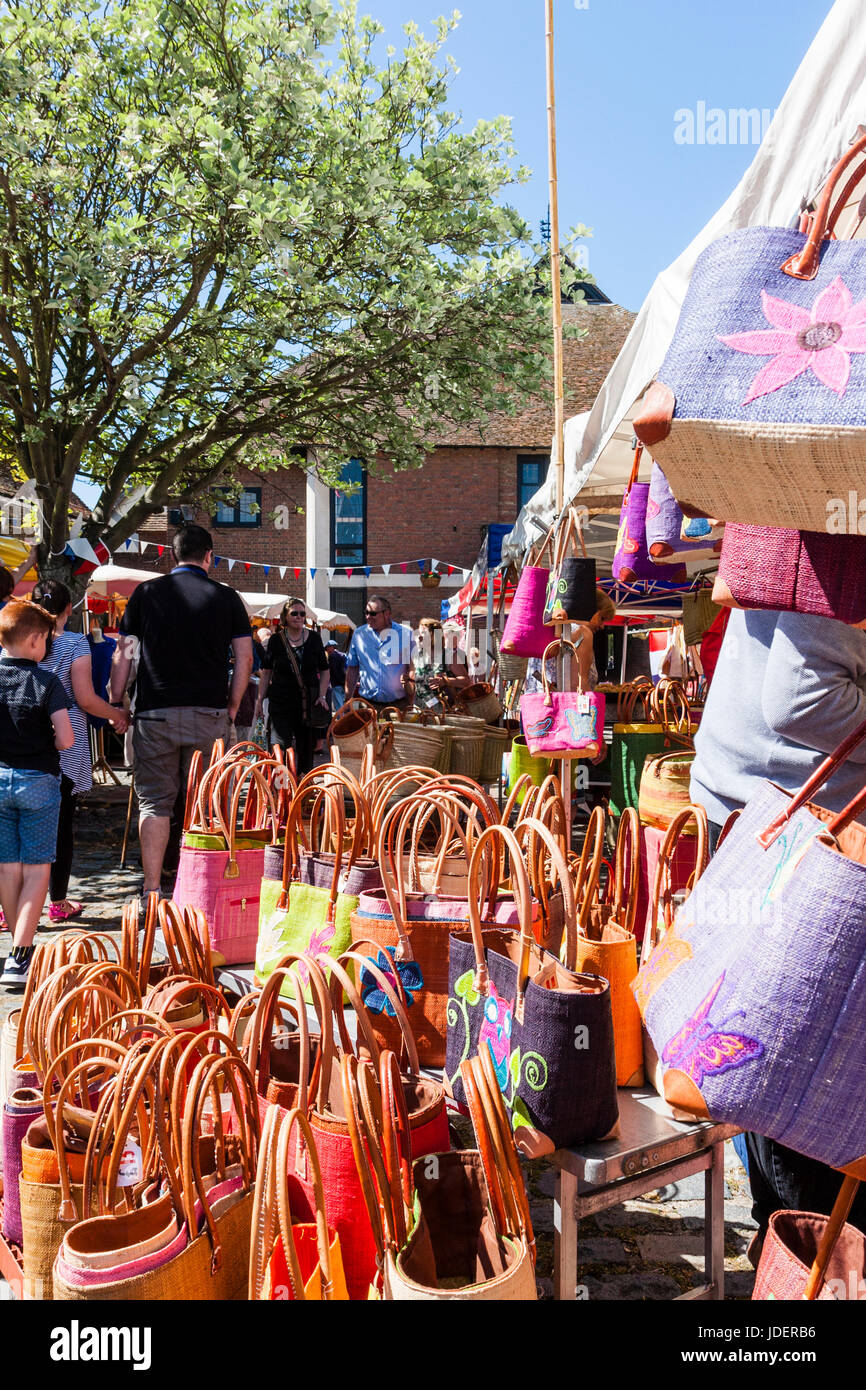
left=632, top=723, right=866, bottom=1177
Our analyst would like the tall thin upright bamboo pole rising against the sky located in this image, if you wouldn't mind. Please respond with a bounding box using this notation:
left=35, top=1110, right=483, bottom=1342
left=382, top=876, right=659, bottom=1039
left=545, top=0, right=571, bottom=849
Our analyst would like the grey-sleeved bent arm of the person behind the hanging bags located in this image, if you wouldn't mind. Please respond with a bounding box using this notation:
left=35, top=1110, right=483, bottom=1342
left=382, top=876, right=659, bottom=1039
left=760, top=613, right=866, bottom=763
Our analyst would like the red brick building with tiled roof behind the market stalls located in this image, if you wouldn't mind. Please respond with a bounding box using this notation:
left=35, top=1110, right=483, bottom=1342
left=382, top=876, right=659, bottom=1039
left=115, top=298, right=634, bottom=636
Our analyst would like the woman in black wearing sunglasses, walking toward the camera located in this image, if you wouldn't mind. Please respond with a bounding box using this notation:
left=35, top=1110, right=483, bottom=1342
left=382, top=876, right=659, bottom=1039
left=253, top=599, right=331, bottom=777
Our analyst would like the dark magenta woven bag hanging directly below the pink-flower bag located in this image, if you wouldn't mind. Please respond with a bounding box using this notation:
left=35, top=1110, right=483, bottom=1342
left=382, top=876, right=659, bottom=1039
left=713, top=521, right=866, bottom=627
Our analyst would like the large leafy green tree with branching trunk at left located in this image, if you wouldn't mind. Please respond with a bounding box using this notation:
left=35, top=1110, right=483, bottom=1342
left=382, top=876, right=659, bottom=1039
left=0, top=0, right=575, bottom=581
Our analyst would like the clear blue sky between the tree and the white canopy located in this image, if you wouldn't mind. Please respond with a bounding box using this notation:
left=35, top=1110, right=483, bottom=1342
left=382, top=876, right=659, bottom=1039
left=369, top=0, right=831, bottom=310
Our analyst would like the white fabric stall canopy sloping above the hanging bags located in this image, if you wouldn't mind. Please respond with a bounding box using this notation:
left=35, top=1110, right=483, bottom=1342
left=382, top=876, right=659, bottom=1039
left=503, top=0, right=866, bottom=559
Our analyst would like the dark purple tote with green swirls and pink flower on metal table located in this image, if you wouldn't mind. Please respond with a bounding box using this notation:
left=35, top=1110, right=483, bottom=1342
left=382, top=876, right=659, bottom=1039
left=445, top=817, right=619, bottom=1156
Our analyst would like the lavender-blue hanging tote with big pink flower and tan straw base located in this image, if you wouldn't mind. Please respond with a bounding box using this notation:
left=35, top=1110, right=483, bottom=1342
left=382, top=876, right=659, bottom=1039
left=634, top=136, right=866, bottom=534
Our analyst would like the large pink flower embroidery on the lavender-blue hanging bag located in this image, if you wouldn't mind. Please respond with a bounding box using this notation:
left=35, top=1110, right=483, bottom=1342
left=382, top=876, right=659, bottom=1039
left=719, top=275, right=866, bottom=406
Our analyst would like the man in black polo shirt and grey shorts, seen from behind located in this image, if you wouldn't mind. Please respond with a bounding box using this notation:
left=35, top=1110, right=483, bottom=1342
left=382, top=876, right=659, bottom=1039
left=111, top=525, right=253, bottom=892
